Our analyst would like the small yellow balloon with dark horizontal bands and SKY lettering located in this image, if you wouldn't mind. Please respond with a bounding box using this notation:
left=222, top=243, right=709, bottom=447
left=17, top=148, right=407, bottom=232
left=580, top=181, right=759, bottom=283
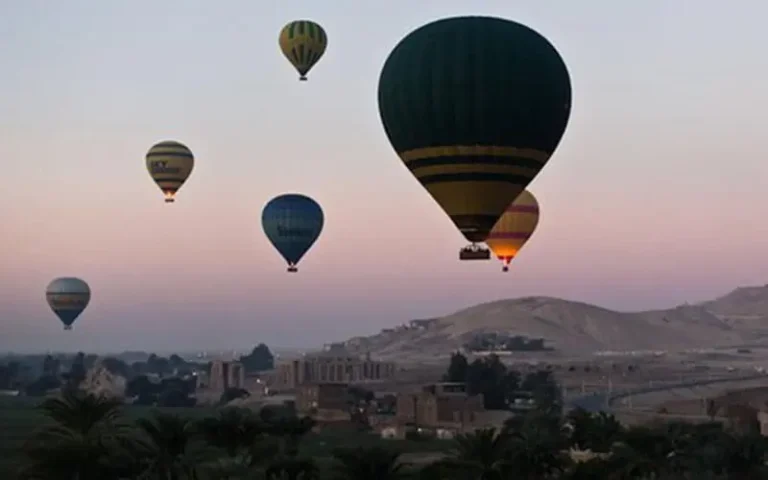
left=147, top=140, right=195, bottom=203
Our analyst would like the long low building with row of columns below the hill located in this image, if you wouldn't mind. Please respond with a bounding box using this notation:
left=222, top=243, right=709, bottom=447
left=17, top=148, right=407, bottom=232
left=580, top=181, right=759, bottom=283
left=274, top=344, right=396, bottom=389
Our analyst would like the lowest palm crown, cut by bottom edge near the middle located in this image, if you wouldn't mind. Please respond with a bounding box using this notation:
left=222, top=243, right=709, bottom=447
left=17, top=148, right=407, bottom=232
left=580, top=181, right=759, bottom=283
left=333, top=447, right=405, bottom=480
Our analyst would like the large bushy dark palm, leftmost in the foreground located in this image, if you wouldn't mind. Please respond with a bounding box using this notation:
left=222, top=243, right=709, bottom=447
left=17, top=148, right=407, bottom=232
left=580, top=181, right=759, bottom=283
left=20, top=390, right=139, bottom=480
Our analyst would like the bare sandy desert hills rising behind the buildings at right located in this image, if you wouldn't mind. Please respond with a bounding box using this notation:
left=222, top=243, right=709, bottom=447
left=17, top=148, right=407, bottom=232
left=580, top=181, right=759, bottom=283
left=344, top=286, right=768, bottom=360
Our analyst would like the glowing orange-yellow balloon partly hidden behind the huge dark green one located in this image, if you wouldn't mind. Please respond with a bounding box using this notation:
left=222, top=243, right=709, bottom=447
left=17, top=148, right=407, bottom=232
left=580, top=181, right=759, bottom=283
left=485, top=190, right=539, bottom=272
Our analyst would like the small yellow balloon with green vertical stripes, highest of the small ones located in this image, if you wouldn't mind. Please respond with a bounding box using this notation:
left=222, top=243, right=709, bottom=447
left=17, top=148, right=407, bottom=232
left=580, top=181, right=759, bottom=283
left=280, top=20, right=328, bottom=81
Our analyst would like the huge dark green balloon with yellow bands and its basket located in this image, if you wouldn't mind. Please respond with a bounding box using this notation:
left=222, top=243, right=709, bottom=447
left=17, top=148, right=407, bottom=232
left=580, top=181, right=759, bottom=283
left=378, top=17, right=571, bottom=260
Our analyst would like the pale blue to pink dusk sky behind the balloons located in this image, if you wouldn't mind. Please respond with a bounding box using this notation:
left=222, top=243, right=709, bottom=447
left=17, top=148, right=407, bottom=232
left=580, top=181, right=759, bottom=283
left=0, top=0, right=768, bottom=351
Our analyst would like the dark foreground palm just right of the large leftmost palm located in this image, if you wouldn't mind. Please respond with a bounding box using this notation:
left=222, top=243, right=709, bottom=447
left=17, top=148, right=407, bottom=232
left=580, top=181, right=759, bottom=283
left=136, top=413, right=205, bottom=480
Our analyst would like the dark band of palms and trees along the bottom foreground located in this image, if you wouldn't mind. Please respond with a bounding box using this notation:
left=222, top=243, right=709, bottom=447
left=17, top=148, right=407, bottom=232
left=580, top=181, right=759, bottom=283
left=6, top=391, right=768, bottom=480
